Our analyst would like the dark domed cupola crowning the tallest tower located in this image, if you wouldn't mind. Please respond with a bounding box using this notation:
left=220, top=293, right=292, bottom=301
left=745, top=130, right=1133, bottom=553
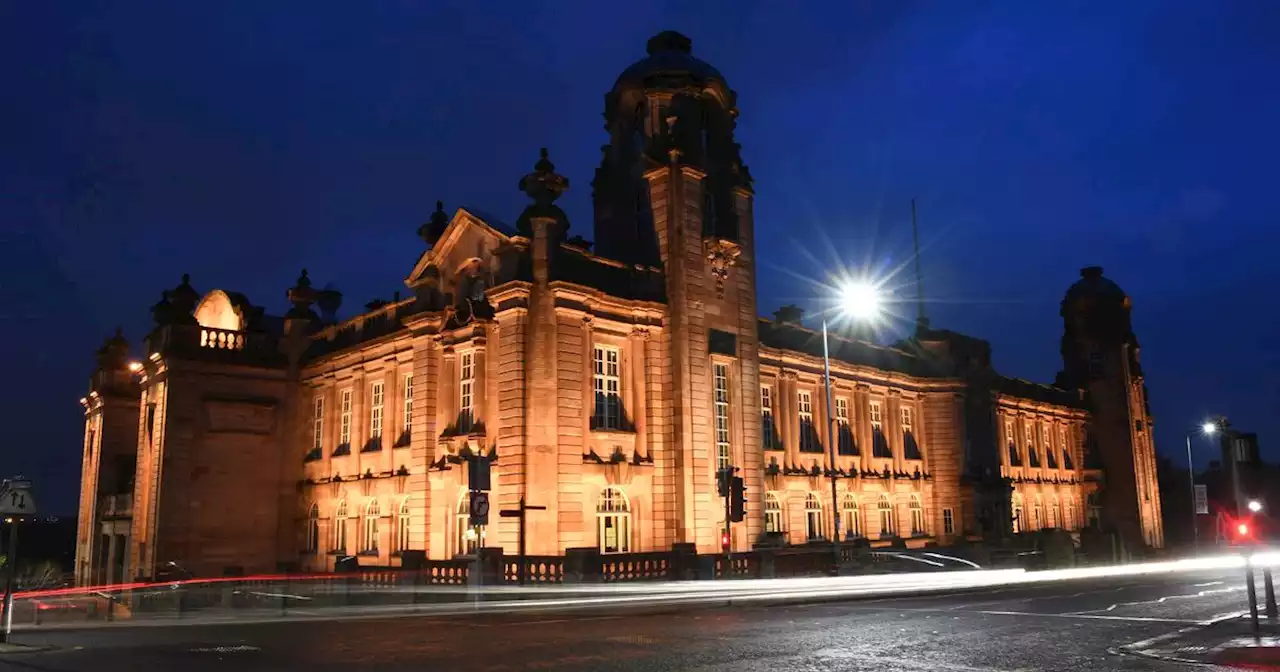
left=591, top=31, right=751, bottom=265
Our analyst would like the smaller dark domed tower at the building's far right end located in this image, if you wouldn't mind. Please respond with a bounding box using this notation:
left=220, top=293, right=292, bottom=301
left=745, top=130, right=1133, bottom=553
left=1061, top=266, right=1165, bottom=548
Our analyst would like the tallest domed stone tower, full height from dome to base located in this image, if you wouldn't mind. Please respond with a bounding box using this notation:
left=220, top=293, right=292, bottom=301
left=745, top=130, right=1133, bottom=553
left=593, top=32, right=764, bottom=553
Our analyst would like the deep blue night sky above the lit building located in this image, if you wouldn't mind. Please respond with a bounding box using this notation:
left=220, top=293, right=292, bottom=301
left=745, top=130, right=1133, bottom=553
left=0, top=0, right=1280, bottom=512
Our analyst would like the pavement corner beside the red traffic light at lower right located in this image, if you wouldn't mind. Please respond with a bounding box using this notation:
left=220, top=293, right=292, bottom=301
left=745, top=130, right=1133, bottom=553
left=1120, top=613, right=1280, bottom=671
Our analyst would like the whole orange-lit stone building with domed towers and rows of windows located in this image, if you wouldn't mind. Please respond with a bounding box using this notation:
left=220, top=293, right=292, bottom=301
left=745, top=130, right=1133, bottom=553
left=78, top=33, right=1162, bottom=582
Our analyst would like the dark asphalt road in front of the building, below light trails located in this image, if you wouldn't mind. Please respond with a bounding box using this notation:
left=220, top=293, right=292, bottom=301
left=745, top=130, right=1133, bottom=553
left=0, top=571, right=1247, bottom=672
